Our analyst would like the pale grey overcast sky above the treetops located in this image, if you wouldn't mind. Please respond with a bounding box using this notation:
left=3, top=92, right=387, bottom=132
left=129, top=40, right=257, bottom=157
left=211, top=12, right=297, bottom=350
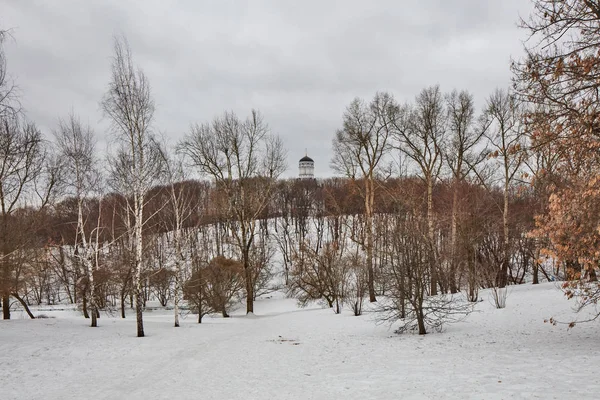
left=0, top=0, right=531, bottom=177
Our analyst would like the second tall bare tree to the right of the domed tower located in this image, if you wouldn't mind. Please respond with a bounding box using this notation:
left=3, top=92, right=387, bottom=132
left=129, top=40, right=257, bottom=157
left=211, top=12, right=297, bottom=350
left=394, top=86, right=447, bottom=295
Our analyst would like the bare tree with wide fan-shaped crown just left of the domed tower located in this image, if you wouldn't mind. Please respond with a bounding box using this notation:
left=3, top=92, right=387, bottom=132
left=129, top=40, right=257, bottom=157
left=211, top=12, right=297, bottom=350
left=180, top=110, right=286, bottom=313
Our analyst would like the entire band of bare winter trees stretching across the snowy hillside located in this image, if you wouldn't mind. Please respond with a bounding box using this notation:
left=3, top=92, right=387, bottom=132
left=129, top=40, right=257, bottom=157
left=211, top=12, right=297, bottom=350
left=0, top=0, right=600, bottom=336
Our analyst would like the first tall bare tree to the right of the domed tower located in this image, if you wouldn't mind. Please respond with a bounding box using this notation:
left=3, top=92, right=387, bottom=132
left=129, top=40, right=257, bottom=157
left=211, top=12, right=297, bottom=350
left=331, top=93, right=397, bottom=302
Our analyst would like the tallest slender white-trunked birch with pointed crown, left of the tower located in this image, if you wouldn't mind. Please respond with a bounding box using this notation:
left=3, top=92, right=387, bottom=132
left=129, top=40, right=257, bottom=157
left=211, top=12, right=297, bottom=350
left=101, top=37, right=163, bottom=337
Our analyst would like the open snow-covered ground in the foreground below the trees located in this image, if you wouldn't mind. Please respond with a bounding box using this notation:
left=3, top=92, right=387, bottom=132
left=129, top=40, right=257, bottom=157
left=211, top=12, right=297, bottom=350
left=0, top=283, right=600, bottom=400
